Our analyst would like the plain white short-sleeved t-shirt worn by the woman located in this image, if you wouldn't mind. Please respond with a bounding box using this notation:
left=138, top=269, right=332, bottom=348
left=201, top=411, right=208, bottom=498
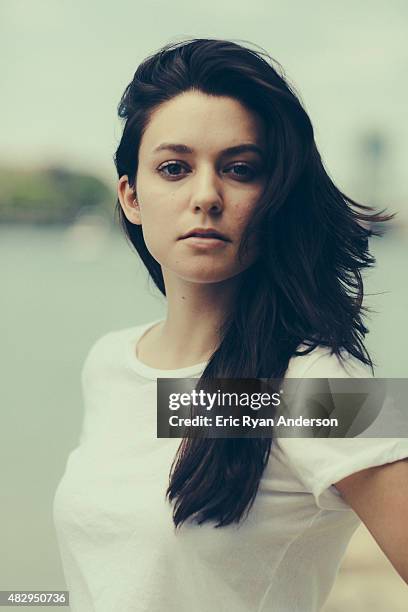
left=54, top=321, right=408, bottom=612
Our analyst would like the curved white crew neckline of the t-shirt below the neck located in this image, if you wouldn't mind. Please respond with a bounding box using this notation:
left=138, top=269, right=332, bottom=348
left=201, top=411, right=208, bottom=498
left=128, top=319, right=208, bottom=380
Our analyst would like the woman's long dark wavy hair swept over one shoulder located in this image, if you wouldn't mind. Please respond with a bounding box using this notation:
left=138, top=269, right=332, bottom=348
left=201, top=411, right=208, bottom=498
left=115, top=39, right=393, bottom=527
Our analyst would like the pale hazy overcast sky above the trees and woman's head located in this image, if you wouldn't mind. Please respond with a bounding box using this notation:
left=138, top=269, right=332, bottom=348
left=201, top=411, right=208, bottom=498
left=0, top=0, right=408, bottom=208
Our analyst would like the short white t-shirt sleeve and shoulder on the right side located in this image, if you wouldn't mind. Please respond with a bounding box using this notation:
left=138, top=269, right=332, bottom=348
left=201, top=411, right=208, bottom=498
left=275, top=350, right=408, bottom=510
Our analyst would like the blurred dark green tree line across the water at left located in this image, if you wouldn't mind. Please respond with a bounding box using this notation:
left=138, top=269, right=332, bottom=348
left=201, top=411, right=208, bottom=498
left=0, top=167, right=115, bottom=223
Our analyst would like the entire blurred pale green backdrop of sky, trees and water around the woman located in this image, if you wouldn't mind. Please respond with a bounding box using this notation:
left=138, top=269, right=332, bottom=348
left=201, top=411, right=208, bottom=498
left=0, top=0, right=408, bottom=612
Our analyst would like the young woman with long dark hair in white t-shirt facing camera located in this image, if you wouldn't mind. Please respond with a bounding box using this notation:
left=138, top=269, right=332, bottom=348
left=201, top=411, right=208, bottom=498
left=54, top=39, right=408, bottom=612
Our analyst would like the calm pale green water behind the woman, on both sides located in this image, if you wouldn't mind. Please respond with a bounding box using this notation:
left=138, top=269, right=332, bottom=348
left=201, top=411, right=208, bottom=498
left=0, top=226, right=408, bottom=604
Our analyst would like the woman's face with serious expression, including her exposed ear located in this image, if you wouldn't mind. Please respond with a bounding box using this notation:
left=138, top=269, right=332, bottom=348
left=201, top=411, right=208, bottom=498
left=118, top=91, right=266, bottom=283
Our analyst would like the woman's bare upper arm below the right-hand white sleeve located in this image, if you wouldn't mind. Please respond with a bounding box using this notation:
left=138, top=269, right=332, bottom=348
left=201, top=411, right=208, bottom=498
left=334, top=459, right=408, bottom=584
